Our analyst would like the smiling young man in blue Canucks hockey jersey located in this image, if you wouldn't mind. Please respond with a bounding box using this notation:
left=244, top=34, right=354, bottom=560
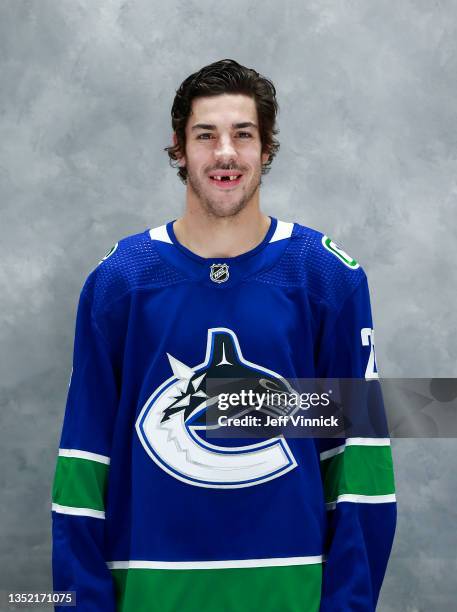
left=52, top=60, right=396, bottom=612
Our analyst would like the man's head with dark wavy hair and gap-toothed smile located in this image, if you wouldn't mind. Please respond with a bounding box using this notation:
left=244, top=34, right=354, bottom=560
left=165, top=59, right=279, bottom=217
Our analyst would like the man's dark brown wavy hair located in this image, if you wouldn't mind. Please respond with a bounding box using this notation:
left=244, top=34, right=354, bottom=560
left=164, top=59, right=279, bottom=183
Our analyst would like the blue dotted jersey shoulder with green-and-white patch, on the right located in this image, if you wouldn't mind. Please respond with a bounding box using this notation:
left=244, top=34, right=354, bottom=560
left=259, top=223, right=366, bottom=309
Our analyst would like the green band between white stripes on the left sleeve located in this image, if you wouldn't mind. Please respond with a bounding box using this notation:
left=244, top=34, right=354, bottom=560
left=52, top=456, right=109, bottom=511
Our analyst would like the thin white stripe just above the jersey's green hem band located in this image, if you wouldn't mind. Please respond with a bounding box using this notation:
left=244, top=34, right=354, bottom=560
left=107, top=555, right=323, bottom=570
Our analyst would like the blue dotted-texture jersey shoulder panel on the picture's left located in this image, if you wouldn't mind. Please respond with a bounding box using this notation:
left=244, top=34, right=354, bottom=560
left=81, top=226, right=184, bottom=314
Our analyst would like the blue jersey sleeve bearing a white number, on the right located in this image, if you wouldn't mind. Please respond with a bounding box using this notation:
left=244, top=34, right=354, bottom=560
left=318, top=272, right=396, bottom=612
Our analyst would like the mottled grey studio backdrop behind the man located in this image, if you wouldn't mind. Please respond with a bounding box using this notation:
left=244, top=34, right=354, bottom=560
left=0, top=0, right=457, bottom=612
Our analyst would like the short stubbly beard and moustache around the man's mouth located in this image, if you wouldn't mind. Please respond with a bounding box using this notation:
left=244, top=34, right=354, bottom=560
left=187, top=161, right=262, bottom=218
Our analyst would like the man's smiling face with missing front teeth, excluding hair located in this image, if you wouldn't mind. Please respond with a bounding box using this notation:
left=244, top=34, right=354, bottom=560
left=176, top=94, right=268, bottom=217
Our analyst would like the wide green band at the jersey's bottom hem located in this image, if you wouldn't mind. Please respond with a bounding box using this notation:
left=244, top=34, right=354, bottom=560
left=112, top=564, right=322, bottom=612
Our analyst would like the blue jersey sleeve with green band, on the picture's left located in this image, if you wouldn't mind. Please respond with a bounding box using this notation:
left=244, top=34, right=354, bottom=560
left=51, top=283, right=118, bottom=612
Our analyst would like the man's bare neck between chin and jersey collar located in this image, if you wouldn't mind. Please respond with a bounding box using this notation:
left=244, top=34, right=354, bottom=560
left=173, top=206, right=271, bottom=258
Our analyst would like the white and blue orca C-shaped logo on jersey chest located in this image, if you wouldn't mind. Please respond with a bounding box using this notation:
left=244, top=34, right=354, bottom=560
left=136, top=327, right=297, bottom=489
